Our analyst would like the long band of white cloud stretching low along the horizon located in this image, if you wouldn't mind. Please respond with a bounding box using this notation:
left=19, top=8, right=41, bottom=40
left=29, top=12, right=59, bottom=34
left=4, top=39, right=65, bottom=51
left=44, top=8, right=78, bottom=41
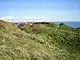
left=0, top=16, right=80, bottom=22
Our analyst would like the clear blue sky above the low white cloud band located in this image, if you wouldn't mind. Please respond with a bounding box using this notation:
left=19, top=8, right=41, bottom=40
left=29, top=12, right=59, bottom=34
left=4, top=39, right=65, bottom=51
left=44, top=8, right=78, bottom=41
left=0, top=0, right=80, bottom=21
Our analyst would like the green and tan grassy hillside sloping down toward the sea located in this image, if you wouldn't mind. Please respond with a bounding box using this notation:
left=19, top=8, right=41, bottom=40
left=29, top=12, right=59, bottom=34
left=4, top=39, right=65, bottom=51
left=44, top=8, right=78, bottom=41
left=0, top=20, right=80, bottom=60
